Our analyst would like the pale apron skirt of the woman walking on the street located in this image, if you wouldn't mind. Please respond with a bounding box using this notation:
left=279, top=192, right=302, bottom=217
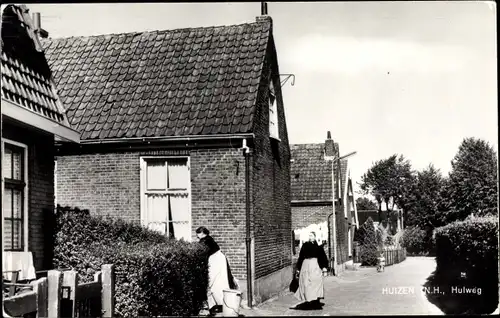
left=295, top=258, right=324, bottom=301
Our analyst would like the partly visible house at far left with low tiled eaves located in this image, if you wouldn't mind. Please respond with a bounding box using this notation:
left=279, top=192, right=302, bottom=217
left=1, top=5, right=79, bottom=278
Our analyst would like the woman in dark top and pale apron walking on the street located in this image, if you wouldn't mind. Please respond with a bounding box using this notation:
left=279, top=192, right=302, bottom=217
left=294, top=232, right=328, bottom=309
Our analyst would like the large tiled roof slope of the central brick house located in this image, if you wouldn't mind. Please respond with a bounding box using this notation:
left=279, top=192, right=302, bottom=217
left=44, top=19, right=271, bottom=140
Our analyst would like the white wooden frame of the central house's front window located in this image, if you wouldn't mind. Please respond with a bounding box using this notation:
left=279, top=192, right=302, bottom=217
left=139, top=156, right=193, bottom=242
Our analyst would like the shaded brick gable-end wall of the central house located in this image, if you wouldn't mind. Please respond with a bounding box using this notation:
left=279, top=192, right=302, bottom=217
left=252, top=40, right=292, bottom=279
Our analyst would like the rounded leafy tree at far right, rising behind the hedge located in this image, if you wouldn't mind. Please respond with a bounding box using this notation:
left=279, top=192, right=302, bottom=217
left=443, top=138, right=498, bottom=222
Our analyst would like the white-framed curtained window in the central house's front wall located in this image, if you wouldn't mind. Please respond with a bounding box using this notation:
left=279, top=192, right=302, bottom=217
left=141, top=157, right=191, bottom=241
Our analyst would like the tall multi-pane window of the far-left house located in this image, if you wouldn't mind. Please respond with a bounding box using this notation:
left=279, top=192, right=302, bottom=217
left=2, top=139, right=28, bottom=251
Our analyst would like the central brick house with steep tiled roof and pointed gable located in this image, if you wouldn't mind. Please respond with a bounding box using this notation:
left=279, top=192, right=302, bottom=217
left=45, top=16, right=292, bottom=302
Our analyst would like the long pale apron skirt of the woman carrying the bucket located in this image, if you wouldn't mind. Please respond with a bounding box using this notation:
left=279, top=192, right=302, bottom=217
left=207, top=251, right=229, bottom=308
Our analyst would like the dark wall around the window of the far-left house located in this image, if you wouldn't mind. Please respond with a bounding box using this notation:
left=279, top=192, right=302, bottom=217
left=2, top=121, right=54, bottom=270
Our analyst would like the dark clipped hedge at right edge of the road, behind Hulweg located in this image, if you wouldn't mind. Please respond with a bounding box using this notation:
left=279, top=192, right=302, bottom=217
left=434, top=217, right=498, bottom=314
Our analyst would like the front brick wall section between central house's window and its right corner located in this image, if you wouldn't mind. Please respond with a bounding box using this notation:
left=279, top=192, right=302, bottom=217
left=191, top=148, right=246, bottom=279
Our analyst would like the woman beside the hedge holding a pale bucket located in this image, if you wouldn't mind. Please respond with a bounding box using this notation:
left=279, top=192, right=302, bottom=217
left=196, top=226, right=237, bottom=312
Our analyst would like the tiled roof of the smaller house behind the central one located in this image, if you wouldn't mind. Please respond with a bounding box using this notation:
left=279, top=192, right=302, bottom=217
left=290, top=143, right=347, bottom=201
